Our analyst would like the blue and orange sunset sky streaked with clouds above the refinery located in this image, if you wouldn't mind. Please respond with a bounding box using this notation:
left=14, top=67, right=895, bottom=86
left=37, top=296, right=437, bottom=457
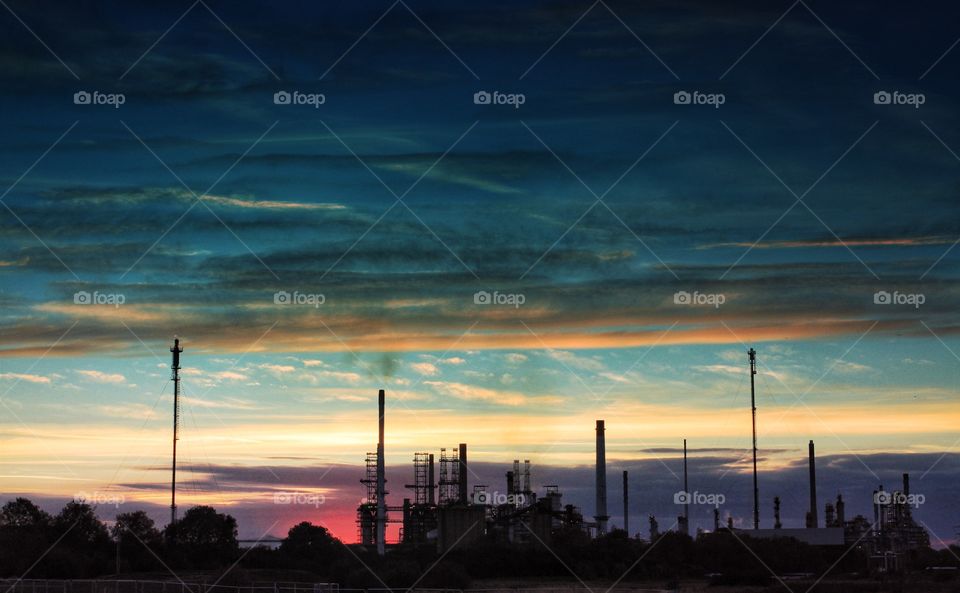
left=0, top=0, right=960, bottom=545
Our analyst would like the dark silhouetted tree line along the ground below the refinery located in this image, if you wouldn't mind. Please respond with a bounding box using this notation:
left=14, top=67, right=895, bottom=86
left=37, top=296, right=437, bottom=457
left=0, top=498, right=960, bottom=589
